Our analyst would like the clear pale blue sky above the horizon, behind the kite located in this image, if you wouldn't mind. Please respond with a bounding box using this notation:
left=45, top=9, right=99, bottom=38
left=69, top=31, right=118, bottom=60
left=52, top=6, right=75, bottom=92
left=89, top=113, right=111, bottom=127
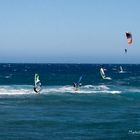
left=0, top=0, right=140, bottom=63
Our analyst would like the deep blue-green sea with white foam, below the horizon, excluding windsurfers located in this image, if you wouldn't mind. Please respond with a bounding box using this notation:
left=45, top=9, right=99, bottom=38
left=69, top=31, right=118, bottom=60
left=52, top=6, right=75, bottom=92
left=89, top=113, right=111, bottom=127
left=0, top=64, right=140, bottom=140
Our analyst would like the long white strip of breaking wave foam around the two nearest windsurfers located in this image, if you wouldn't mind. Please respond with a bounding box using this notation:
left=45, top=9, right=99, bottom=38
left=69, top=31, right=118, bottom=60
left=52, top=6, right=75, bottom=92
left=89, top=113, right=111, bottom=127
left=0, top=85, right=121, bottom=95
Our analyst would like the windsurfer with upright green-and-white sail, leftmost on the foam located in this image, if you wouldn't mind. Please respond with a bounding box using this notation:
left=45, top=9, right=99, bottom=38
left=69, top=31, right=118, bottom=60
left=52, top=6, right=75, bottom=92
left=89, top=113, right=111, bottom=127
left=34, top=73, right=41, bottom=93
